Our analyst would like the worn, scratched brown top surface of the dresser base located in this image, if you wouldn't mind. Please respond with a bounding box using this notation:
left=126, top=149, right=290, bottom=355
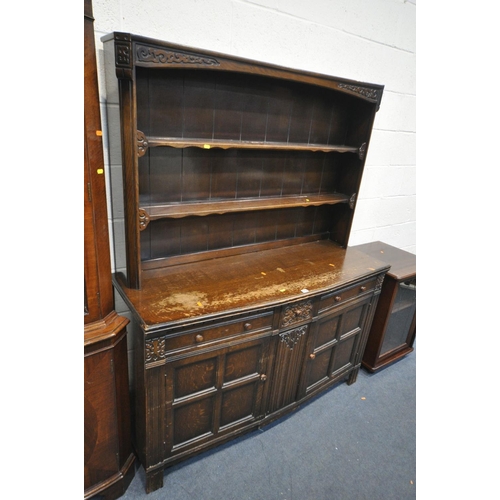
left=114, top=240, right=388, bottom=330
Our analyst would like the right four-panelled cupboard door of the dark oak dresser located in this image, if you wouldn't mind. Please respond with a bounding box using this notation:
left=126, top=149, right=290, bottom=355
left=300, top=299, right=370, bottom=397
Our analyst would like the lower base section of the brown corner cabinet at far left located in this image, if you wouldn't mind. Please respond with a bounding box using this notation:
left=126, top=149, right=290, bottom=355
left=84, top=313, right=135, bottom=500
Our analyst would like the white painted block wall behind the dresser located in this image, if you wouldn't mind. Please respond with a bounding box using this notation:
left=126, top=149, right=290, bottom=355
left=93, top=0, right=416, bottom=258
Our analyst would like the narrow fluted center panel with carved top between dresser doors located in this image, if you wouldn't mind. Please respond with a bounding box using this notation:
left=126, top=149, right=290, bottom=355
left=266, top=325, right=309, bottom=413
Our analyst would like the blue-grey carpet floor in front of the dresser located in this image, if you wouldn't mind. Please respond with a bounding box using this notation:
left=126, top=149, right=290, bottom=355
left=117, top=350, right=416, bottom=500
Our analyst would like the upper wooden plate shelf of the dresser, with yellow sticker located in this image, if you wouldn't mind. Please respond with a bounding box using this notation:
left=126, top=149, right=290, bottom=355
left=143, top=136, right=360, bottom=154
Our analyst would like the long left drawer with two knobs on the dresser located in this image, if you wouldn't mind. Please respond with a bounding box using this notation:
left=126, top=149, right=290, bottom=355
left=160, top=312, right=273, bottom=352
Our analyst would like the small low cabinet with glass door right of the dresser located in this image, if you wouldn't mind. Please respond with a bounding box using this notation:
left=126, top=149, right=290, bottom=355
left=356, top=241, right=417, bottom=372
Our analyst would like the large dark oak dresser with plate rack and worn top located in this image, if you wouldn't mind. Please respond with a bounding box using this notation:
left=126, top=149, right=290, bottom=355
left=103, top=33, right=389, bottom=491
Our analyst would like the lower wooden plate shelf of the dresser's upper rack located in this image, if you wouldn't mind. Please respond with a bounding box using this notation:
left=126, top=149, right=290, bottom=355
left=141, top=193, right=349, bottom=220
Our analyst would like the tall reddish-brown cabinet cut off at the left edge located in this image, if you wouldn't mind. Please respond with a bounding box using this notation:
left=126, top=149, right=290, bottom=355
left=84, top=0, right=135, bottom=500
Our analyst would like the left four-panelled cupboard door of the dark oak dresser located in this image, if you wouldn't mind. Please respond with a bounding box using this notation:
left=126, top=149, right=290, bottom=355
left=167, top=338, right=269, bottom=454
